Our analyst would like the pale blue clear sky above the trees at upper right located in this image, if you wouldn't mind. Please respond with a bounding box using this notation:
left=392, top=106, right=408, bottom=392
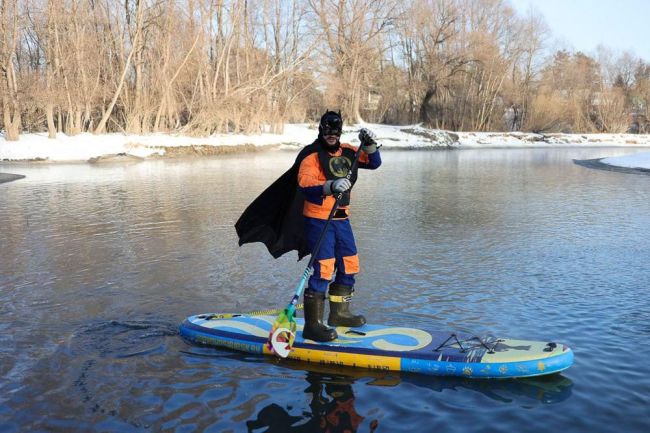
left=510, top=0, right=650, bottom=62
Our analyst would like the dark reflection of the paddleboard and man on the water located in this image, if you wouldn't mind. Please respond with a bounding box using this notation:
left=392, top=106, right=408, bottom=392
left=195, top=347, right=573, bottom=433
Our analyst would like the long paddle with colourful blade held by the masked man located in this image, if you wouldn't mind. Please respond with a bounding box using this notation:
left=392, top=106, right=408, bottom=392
left=267, top=129, right=366, bottom=358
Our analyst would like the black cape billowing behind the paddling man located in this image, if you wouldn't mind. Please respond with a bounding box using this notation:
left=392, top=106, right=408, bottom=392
left=235, top=141, right=320, bottom=260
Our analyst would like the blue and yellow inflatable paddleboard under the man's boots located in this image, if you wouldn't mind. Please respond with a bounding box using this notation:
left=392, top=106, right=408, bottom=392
left=180, top=314, right=573, bottom=378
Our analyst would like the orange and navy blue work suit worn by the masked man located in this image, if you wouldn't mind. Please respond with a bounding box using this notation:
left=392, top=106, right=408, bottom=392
left=298, top=143, right=381, bottom=294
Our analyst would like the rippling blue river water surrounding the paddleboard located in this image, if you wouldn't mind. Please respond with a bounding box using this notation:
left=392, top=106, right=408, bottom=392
left=0, top=148, right=650, bottom=433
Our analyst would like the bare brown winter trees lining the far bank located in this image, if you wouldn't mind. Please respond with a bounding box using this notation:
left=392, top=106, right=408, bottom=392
left=0, top=0, right=650, bottom=139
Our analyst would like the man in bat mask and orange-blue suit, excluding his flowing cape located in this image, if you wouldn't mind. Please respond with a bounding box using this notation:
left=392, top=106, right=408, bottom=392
left=298, top=111, right=381, bottom=341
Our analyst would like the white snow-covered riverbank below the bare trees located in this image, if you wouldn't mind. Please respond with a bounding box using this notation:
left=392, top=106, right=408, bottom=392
left=0, top=124, right=650, bottom=169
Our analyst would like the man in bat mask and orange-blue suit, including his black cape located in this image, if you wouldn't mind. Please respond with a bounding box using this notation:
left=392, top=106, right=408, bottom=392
left=235, top=111, right=381, bottom=342
